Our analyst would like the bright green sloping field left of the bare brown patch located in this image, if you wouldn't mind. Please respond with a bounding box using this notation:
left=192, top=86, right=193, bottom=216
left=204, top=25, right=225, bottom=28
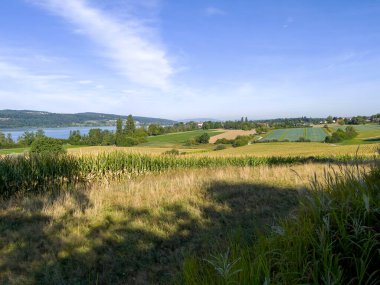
left=141, top=130, right=223, bottom=147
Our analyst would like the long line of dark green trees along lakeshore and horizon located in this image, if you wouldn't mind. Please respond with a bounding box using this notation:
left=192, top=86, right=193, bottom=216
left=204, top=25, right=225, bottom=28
left=0, top=114, right=380, bottom=149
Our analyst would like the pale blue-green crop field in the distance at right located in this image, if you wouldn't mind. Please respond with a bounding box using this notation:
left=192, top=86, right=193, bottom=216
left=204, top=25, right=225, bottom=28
left=264, top=128, right=327, bottom=142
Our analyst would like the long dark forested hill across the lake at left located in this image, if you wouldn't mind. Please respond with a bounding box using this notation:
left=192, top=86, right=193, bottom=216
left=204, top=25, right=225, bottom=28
left=0, top=110, right=175, bottom=129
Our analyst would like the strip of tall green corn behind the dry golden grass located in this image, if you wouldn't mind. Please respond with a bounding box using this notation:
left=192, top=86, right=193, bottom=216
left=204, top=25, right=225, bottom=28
left=0, top=151, right=368, bottom=197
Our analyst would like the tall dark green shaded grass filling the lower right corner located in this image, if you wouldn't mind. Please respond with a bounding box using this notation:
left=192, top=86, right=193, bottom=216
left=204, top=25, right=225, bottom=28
left=181, top=161, right=380, bottom=284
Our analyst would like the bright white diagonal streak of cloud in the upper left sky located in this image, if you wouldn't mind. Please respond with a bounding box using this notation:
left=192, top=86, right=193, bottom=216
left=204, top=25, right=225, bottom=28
left=32, top=0, right=174, bottom=89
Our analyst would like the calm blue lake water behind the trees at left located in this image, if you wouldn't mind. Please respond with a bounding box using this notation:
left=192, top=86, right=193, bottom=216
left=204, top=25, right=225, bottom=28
left=0, top=126, right=116, bottom=141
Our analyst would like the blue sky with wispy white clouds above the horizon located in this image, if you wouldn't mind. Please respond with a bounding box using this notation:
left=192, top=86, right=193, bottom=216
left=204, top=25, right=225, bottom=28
left=0, top=0, right=380, bottom=119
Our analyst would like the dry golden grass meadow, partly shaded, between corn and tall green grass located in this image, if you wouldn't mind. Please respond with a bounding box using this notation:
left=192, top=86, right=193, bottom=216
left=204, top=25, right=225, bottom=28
left=0, top=164, right=366, bottom=284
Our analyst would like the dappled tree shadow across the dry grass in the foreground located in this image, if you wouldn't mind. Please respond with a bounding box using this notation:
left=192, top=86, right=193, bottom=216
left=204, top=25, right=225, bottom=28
left=0, top=182, right=298, bottom=284
